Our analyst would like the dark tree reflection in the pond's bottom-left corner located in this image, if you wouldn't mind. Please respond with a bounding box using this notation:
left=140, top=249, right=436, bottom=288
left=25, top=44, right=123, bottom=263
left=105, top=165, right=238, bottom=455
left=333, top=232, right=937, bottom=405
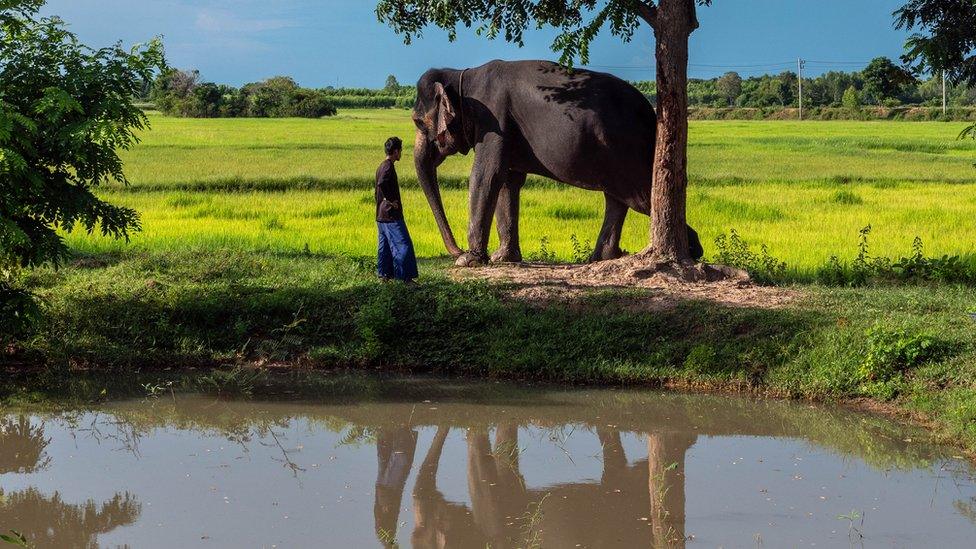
left=0, top=488, right=142, bottom=549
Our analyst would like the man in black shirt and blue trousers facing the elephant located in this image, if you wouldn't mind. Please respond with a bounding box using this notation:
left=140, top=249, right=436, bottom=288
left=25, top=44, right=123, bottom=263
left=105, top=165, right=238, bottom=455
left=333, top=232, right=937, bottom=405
left=376, top=137, right=418, bottom=283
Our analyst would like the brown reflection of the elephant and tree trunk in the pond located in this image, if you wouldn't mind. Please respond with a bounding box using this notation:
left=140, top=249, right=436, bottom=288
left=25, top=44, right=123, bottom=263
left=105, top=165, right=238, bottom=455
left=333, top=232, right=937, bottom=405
left=400, top=424, right=695, bottom=548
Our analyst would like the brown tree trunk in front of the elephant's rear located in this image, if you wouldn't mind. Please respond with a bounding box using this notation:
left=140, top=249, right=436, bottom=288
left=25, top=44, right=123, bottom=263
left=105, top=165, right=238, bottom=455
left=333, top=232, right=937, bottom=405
left=651, top=0, right=698, bottom=262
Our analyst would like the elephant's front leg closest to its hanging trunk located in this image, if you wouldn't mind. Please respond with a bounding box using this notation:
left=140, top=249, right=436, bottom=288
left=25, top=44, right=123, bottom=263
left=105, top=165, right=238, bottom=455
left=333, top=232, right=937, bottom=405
left=455, top=136, right=508, bottom=267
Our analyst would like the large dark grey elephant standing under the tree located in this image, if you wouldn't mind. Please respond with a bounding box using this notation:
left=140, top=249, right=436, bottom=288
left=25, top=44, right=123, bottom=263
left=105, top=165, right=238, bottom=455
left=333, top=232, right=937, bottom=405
left=413, top=61, right=702, bottom=266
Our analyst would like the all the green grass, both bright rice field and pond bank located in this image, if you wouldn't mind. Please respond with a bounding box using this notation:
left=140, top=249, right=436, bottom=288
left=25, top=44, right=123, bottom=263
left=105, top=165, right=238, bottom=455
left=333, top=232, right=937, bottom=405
left=0, top=111, right=976, bottom=451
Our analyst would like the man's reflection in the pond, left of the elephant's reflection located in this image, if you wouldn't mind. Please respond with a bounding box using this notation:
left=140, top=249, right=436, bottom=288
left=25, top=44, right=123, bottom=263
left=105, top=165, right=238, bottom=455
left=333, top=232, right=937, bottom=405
left=373, top=426, right=417, bottom=545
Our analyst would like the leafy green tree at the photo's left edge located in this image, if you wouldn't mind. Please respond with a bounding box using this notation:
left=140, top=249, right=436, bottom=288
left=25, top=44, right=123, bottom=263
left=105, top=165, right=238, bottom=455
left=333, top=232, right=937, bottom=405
left=0, top=0, right=164, bottom=322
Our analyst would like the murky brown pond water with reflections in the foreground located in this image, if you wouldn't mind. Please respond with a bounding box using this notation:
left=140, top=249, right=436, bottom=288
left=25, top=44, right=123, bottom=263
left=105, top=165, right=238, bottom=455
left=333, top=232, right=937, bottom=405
left=0, top=380, right=976, bottom=548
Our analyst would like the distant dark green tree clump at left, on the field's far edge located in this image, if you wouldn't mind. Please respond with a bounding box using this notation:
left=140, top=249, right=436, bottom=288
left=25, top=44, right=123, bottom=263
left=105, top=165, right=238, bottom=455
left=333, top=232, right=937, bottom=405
left=150, top=69, right=336, bottom=118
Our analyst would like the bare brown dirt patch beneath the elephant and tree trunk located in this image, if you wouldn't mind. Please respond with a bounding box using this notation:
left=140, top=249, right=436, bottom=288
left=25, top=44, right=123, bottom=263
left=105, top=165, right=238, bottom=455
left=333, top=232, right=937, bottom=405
left=451, top=256, right=800, bottom=311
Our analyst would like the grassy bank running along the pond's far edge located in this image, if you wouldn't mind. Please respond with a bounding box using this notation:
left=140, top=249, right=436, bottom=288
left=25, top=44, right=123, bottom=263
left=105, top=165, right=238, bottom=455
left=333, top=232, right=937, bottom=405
left=4, top=251, right=976, bottom=450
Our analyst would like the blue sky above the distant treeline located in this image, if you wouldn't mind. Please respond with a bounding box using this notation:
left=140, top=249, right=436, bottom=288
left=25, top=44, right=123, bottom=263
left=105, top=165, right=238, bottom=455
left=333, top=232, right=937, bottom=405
left=45, top=0, right=905, bottom=87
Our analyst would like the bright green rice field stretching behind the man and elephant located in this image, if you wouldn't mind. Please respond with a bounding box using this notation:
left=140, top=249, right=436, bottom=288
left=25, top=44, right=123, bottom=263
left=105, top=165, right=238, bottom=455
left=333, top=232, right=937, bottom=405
left=68, top=110, right=976, bottom=271
